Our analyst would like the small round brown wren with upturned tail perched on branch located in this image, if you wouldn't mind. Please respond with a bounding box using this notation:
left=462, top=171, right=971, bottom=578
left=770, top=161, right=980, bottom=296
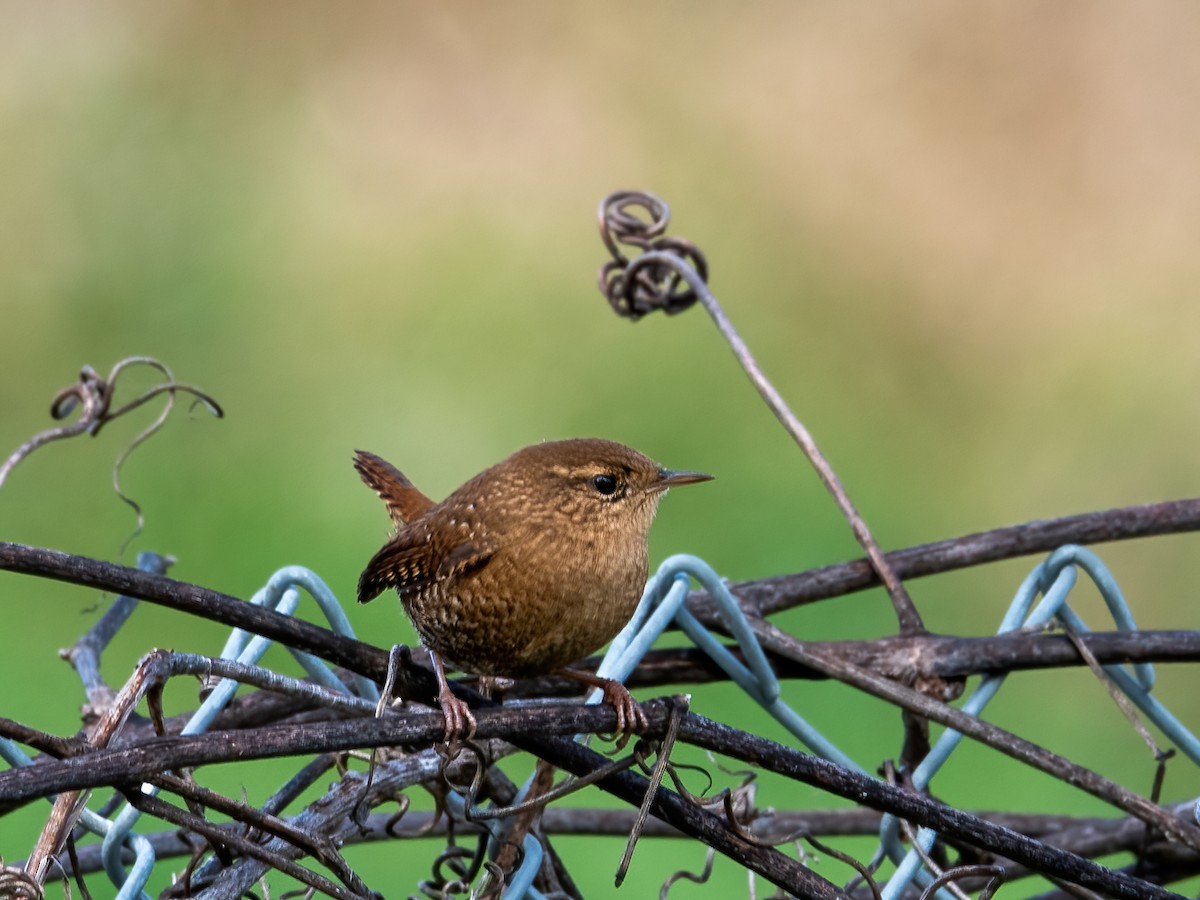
left=354, top=439, right=712, bottom=740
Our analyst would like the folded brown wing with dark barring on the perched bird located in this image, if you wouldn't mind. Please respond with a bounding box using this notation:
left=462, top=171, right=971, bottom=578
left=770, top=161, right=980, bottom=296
left=359, top=522, right=496, bottom=604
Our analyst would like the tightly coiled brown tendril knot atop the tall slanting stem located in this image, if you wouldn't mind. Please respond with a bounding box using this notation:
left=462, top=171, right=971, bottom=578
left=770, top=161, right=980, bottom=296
left=598, top=191, right=708, bottom=322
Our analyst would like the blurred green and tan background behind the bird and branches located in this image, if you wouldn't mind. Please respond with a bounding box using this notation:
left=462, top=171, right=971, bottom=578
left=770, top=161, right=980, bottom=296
left=0, top=1, right=1200, bottom=896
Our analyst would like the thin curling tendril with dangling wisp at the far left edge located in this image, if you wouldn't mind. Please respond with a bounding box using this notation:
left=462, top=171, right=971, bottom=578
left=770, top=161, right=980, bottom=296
left=0, top=356, right=224, bottom=544
